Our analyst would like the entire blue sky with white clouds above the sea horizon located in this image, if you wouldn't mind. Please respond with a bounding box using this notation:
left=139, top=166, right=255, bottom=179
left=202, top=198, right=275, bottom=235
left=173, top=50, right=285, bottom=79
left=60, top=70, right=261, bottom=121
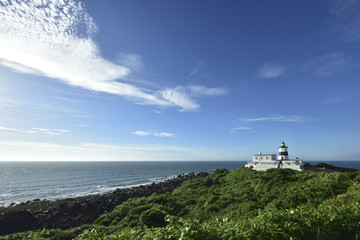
left=0, top=0, right=360, bottom=161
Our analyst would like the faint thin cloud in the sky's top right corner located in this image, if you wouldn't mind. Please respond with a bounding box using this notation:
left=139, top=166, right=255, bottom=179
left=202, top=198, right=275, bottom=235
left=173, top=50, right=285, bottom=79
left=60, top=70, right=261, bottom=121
left=330, top=0, right=360, bottom=42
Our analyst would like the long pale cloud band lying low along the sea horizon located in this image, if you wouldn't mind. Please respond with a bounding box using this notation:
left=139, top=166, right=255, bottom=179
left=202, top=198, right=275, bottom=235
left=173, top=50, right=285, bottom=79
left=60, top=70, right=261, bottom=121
left=0, top=141, right=231, bottom=161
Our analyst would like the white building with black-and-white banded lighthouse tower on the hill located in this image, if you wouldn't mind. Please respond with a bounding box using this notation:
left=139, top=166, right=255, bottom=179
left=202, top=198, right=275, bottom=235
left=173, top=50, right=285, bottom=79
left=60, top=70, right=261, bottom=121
left=245, top=142, right=304, bottom=171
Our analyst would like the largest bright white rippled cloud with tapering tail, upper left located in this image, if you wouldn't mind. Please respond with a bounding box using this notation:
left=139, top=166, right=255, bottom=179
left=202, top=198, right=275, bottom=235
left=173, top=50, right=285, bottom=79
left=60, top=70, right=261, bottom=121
left=0, top=0, right=225, bottom=111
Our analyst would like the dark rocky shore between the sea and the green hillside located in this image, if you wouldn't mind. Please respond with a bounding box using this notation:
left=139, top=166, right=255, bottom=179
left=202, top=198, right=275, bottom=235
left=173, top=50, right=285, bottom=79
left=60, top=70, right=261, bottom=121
left=0, top=172, right=209, bottom=235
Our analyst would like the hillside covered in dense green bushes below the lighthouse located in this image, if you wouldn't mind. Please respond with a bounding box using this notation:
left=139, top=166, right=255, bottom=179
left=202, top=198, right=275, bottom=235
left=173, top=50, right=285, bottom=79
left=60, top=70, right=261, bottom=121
left=4, top=167, right=360, bottom=239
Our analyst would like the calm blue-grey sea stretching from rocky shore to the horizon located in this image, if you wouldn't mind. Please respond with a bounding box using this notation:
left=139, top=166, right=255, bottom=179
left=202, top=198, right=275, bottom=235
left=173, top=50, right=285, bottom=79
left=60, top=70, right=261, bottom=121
left=0, top=161, right=360, bottom=206
